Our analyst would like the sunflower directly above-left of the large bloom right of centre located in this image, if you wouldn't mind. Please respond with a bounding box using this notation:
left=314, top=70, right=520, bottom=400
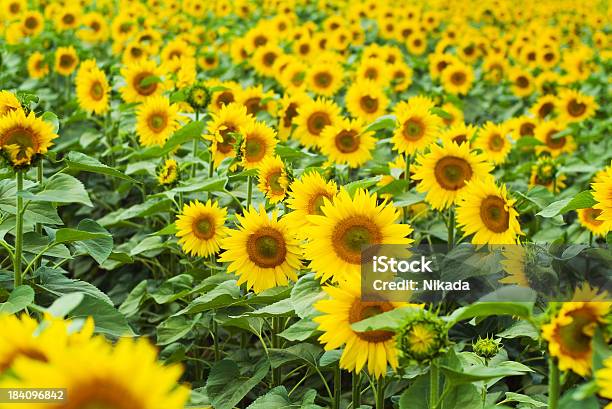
left=391, top=103, right=442, bottom=155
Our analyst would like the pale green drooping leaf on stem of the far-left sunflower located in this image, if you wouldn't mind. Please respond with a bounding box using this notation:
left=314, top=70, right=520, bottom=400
left=21, top=173, right=93, bottom=207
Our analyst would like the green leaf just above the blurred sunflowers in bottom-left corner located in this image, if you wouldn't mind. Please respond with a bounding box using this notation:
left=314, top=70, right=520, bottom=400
left=69, top=295, right=135, bottom=337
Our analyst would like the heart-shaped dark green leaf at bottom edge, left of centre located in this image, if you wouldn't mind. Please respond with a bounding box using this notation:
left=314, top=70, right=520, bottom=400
left=206, top=359, right=270, bottom=409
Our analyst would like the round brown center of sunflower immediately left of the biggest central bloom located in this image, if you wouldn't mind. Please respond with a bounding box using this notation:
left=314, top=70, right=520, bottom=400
left=247, top=227, right=287, bottom=268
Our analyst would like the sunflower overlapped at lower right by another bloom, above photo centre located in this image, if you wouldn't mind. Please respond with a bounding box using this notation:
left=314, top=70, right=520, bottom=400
left=294, top=98, right=340, bottom=147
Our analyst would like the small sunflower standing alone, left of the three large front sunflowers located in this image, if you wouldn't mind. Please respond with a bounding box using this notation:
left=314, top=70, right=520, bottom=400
left=175, top=200, right=229, bottom=257
